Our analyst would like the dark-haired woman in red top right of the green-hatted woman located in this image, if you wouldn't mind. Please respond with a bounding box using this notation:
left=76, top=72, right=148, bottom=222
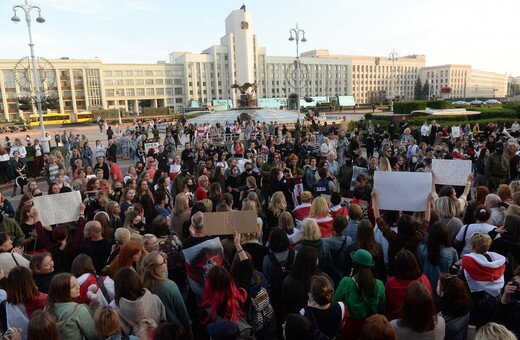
left=385, top=250, right=433, bottom=320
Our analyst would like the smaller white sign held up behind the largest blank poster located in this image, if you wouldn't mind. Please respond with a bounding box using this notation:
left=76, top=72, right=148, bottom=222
left=432, top=159, right=471, bottom=186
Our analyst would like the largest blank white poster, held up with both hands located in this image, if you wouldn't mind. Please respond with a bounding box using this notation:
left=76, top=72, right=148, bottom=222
left=374, top=171, right=432, bottom=211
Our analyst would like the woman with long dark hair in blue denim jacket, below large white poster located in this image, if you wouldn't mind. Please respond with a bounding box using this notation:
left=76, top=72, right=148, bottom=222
left=417, top=222, right=459, bottom=290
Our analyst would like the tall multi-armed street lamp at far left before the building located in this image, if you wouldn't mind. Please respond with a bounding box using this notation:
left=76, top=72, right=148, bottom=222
left=11, top=0, right=50, bottom=152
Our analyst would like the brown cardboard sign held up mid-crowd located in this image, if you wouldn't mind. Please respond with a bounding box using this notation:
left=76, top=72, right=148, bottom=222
left=204, top=210, right=257, bottom=235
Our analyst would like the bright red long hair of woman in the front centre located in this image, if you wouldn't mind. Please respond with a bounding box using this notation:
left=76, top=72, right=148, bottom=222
left=202, top=266, right=247, bottom=323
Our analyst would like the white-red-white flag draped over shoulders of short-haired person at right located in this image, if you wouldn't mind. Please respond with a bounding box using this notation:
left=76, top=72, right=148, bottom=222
left=462, top=252, right=506, bottom=296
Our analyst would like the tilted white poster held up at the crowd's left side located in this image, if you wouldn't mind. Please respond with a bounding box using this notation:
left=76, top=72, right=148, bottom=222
left=33, top=191, right=81, bottom=225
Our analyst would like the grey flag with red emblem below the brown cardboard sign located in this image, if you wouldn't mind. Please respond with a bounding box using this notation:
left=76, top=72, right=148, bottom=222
left=182, top=237, right=224, bottom=296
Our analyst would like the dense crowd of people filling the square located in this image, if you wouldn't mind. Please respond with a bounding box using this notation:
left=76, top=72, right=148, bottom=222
left=0, top=117, right=520, bottom=340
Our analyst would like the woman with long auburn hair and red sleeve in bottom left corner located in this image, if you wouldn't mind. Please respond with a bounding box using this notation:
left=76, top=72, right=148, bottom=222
left=4, top=266, right=47, bottom=334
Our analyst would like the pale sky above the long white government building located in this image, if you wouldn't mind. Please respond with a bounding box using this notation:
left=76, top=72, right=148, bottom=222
left=0, top=0, right=520, bottom=76
